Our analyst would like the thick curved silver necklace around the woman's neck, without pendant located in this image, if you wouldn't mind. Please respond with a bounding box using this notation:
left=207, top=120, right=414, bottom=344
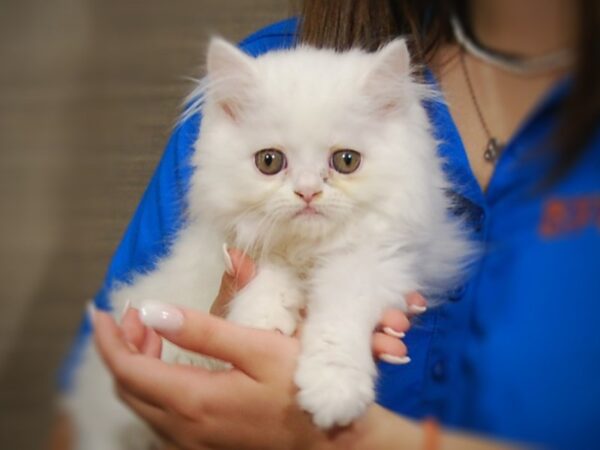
left=450, top=15, right=575, bottom=75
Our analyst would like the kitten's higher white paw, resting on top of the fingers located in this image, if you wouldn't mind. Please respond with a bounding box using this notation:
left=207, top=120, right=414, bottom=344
left=227, top=288, right=300, bottom=336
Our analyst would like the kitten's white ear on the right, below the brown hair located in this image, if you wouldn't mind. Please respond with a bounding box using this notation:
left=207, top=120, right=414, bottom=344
left=364, top=39, right=411, bottom=113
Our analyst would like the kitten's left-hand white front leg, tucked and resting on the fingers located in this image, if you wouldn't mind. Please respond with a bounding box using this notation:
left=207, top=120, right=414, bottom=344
left=227, top=264, right=304, bottom=336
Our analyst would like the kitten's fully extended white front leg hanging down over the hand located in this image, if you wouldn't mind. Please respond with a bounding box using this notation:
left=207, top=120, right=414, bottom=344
left=295, top=250, right=409, bottom=428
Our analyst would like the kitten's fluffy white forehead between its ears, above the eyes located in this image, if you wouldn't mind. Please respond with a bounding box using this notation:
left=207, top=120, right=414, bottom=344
left=238, top=48, right=372, bottom=139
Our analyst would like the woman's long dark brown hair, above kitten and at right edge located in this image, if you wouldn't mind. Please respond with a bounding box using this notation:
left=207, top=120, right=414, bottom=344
left=300, top=0, right=600, bottom=181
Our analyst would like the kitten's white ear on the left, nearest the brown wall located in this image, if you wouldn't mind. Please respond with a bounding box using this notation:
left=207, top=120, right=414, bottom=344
left=206, top=38, right=257, bottom=121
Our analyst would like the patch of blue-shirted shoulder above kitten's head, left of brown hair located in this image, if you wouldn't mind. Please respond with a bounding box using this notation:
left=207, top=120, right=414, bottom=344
left=239, top=17, right=298, bottom=56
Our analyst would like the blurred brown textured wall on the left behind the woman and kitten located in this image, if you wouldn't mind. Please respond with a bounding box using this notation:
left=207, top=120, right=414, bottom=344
left=0, top=0, right=290, bottom=450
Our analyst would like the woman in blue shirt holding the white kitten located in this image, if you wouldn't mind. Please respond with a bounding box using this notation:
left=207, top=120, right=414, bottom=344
left=52, top=0, right=600, bottom=449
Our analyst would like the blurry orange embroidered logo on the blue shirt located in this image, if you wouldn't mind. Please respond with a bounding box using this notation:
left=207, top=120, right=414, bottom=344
left=539, top=195, right=600, bottom=238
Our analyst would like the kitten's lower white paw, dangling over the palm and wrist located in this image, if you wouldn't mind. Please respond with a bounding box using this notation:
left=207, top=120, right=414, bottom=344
left=294, top=355, right=375, bottom=429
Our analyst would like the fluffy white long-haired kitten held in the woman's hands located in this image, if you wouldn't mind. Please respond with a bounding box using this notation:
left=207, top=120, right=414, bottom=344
left=65, top=39, right=470, bottom=450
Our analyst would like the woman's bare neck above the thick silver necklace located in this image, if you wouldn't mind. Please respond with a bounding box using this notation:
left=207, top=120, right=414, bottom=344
left=469, top=0, right=577, bottom=56
